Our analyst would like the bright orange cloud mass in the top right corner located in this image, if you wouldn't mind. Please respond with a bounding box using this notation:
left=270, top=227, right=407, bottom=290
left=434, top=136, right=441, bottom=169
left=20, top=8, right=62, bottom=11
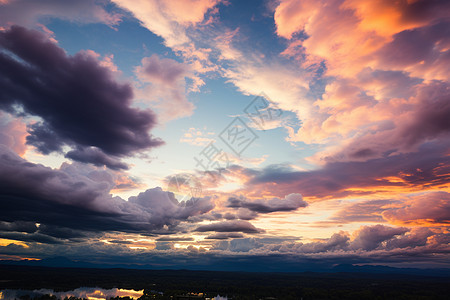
left=274, top=0, right=450, bottom=77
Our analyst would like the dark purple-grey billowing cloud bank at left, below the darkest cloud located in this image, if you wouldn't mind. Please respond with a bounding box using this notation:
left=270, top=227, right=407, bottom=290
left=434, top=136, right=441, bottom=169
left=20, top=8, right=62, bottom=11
left=0, top=145, right=214, bottom=241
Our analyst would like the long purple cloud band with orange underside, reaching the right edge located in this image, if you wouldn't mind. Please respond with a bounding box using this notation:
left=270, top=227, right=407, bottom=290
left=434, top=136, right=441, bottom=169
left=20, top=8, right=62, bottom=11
left=237, top=141, right=449, bottom=199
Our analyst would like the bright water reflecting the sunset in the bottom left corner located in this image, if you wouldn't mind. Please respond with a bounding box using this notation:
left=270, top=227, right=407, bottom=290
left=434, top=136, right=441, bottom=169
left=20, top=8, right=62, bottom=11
left=0, top=287, right=144, bottom=300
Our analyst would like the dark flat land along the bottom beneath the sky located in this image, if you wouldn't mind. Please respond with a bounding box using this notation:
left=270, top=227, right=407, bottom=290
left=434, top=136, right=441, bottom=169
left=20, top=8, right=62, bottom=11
left=0, top=265, right=450, bottom=300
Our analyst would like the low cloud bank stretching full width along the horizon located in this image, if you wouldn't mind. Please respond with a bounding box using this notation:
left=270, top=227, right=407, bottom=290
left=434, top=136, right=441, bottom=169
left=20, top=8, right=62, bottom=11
left=0, top=226, right=450, bottom=271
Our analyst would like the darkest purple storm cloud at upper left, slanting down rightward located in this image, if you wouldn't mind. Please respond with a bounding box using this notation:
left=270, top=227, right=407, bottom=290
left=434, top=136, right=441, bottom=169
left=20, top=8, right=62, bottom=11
left=0, top=26, right=162, bottom=169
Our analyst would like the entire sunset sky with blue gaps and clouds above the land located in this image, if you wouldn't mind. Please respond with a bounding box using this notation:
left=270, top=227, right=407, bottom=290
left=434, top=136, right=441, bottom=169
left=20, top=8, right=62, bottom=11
left=0, top=0, right=450, bottom=271
